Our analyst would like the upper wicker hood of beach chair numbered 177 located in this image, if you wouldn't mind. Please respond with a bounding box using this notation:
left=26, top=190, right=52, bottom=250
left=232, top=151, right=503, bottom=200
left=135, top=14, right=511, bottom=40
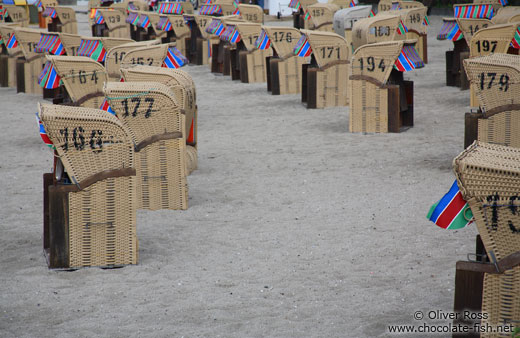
left=103, top=82, right=185, bottom=149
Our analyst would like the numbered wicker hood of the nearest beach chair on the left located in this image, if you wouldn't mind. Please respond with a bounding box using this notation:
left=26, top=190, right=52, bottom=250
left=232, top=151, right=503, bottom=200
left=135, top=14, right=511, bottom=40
left=38, top=104, right=134, bottom=188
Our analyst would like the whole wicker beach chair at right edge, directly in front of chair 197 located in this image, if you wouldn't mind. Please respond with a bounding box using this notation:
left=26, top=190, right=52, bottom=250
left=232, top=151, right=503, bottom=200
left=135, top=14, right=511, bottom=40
left=465, top=54, right=520, bottom=148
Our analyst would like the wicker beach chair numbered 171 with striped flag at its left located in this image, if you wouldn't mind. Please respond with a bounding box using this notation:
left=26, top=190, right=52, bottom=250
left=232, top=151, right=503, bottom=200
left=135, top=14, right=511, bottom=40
left=294, top=29, right=350, bottom=108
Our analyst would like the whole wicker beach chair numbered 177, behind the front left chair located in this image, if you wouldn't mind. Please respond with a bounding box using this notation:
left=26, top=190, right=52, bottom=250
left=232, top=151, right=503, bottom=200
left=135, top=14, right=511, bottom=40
left=104, top=82, right=188, bottom=210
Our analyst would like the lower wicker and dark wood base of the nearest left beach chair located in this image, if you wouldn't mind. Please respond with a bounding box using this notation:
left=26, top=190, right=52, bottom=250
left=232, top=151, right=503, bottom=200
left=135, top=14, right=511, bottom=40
left=43, top=174, right=138, bottom=269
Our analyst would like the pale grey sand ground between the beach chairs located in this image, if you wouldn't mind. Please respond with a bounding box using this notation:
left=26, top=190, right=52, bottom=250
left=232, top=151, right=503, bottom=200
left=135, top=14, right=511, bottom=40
left=0, top=15, right=476, bottom=337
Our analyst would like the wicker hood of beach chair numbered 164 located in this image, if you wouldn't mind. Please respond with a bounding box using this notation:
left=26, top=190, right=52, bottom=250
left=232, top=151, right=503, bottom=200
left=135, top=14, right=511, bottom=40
left=47, top=56, right=108, bottom=109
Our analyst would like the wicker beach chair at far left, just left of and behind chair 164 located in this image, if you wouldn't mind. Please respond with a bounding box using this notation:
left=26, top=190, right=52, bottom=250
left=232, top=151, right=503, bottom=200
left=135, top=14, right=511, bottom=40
left=14, top=27, right=45, bottom=95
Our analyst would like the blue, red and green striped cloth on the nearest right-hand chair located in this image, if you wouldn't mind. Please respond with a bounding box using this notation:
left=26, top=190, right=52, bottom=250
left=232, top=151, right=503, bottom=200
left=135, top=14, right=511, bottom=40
left=426, top=181, right=473, bottom=230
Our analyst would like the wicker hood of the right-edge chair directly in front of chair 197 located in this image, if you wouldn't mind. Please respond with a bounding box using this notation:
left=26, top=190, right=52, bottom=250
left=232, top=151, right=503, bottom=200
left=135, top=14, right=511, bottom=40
left=464, top=54, right=520, bottom=117
